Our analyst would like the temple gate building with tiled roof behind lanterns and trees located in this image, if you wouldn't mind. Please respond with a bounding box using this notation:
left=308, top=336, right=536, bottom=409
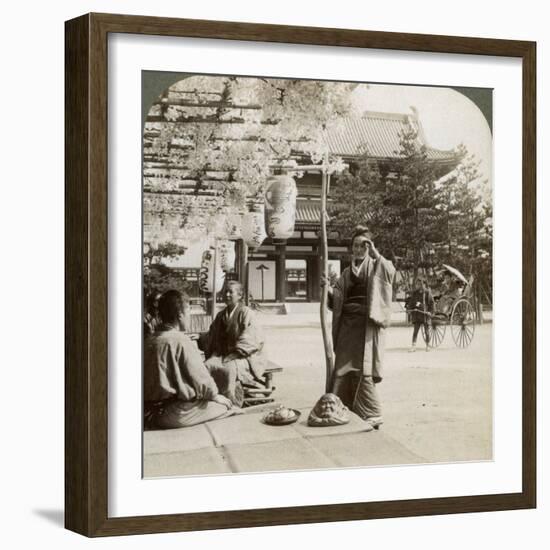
left=248, top=110, right=459, bottom=302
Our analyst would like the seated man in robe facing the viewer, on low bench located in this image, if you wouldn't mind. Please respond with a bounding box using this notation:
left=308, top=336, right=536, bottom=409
left=205, top=281, right=265, bottom=407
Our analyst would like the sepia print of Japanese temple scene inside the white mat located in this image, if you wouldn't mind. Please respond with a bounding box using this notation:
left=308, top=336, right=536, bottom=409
left=142, top=71, right=494, bottom=478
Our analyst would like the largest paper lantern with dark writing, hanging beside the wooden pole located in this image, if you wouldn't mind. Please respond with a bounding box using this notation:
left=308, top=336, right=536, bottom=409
left=265, top=176, right=298, bottom=242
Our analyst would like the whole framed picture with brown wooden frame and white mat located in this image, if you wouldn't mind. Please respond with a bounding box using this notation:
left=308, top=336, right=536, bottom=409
left=65, top=14, right=536, bottom=536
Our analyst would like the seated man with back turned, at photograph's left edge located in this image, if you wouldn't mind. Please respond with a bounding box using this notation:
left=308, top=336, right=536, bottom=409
left=143, top=290, right=237, bottom=428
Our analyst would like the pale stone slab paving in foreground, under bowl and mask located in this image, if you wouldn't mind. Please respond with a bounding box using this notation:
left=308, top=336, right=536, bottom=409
left=143, top=405, right=424, bottom=477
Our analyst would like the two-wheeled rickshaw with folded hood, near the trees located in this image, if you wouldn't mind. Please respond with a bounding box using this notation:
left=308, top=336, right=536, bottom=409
left=409, top=264, right=476, bottom=348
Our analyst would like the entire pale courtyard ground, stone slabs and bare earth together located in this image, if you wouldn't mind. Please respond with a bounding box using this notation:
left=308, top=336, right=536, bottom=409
left=144, top=313, right=493, bottom=477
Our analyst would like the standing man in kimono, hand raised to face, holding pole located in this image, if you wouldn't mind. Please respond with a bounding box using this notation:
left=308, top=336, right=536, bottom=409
left=324, top=226, right=395, bottom=431
